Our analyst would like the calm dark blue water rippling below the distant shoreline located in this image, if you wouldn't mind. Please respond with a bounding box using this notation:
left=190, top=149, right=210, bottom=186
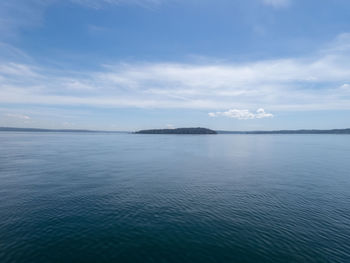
left=0, top=132, right=350, bottom=263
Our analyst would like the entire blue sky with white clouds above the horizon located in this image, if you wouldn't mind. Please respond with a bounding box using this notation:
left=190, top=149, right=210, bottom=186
left=0, top=0, right=350, bottom=131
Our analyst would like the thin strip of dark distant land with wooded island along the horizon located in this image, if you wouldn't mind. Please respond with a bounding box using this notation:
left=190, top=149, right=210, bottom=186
left=0, top=127, right=350, bottom=135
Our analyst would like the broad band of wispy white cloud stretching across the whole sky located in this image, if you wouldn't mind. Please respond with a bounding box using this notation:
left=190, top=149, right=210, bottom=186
left=0, top=34, right=350, bottom=111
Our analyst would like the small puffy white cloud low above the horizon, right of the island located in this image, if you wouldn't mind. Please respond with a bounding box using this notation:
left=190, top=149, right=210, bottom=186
left=208, top=109, right=273, bottom=120
